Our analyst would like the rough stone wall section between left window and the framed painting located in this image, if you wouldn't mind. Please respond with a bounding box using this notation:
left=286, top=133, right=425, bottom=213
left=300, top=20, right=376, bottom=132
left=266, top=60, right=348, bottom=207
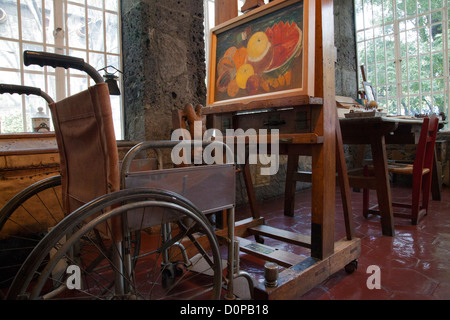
left=122, top=0, right=206, bottom=141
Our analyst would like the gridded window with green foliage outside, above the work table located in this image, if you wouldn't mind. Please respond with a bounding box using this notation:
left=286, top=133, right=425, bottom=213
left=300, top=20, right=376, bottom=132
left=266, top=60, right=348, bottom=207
left=355, top=0, right=450, bottom=117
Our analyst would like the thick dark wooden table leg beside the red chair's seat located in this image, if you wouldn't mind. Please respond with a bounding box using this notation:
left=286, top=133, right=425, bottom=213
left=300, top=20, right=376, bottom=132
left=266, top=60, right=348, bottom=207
left=371, top=135, right=395, bottom=236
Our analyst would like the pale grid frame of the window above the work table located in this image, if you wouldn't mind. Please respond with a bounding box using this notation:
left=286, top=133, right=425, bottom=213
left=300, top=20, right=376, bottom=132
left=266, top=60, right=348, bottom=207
left=354, top=0, right=450, bottom=122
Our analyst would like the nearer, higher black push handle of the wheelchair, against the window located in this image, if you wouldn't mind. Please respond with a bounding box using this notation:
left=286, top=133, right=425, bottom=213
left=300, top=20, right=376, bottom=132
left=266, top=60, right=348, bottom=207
left=23, top=50, right=104, bottom=83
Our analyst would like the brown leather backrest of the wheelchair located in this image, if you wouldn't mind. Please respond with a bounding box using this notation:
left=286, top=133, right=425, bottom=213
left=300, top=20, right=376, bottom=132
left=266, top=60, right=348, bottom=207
left=50, top=83, right=120, bottom=214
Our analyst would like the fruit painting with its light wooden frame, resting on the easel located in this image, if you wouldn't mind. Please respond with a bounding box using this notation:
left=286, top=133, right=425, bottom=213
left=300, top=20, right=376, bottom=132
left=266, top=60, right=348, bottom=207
left=208, top=0, right=314, bottom=109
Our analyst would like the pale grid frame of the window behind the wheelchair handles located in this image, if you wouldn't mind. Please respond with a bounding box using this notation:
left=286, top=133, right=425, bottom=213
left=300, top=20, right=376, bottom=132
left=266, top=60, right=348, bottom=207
left=0, top=0, right=124, bottom=140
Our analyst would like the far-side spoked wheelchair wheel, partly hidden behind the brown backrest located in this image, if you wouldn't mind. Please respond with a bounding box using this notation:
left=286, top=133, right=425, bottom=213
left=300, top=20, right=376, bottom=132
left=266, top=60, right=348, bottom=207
left=0, top=176, right=64, bottom=290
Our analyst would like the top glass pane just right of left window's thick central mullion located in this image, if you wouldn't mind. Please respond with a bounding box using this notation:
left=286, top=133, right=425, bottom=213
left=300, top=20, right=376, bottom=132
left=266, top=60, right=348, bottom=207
left=67, top=4, right=86, bottom=49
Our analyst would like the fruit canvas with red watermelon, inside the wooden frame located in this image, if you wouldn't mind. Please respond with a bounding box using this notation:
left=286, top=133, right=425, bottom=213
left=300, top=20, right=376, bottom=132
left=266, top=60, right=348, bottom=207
left=214, top=1, right=303, bottom=101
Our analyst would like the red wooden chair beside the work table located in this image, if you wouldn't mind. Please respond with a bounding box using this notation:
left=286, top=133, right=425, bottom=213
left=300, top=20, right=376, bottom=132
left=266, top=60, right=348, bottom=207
left=363, top=114, right=439, bottom=225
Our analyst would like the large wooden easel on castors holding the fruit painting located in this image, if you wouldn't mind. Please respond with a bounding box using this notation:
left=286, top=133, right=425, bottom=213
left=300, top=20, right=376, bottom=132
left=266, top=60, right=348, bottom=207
left=203, top=0, right=360, bottom=300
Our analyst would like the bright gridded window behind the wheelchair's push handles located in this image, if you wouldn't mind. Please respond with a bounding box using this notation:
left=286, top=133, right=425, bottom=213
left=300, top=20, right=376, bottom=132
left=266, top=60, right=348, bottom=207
left=0, top=0, right=122, bottom=139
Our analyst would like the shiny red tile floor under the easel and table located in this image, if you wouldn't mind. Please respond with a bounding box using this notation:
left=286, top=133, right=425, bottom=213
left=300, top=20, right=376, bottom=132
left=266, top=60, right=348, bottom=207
left=236, top=187, right=450, bottom=300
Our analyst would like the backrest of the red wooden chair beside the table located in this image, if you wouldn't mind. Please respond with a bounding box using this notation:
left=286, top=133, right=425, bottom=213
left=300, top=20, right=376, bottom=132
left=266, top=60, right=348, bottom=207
left=413, top=114, right=439, bottom=174
